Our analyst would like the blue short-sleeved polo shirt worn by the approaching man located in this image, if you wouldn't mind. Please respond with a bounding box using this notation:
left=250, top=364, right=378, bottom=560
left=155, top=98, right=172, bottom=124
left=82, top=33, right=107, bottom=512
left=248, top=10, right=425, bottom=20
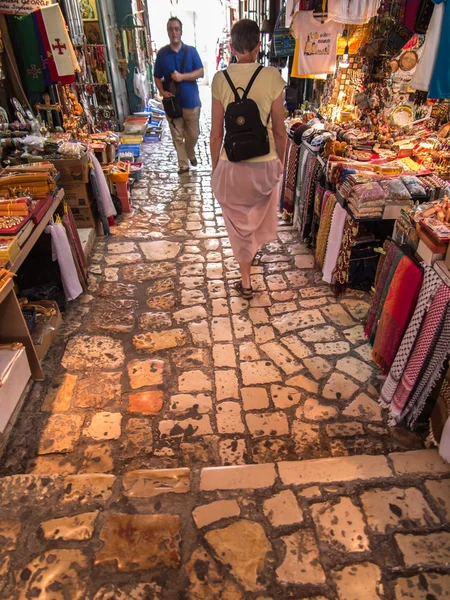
left=154, top=44, right=203, bottom=108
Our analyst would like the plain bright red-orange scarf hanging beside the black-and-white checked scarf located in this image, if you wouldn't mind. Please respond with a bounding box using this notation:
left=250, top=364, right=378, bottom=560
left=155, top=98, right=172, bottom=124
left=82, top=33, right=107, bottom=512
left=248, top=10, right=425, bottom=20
left=372, top=256, right=423, bottom=375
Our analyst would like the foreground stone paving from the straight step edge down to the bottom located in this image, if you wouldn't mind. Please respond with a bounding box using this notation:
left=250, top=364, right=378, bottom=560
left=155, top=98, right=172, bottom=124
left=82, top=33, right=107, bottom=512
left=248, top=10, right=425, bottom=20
left=0, top=450, right=450, bottom=600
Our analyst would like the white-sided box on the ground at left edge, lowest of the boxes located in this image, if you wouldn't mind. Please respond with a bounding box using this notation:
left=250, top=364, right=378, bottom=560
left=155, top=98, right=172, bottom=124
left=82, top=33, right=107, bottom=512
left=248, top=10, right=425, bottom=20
left=0, top=344, right=31, bottom=433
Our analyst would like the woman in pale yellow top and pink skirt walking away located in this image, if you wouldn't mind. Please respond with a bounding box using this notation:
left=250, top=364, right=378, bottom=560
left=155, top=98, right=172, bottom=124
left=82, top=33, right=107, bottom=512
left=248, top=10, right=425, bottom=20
left=211, top=19, right=286, bottom=298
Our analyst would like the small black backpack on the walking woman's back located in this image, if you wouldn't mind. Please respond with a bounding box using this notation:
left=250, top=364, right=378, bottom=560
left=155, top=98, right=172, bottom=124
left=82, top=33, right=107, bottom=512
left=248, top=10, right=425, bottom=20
left=223, top=65, right=270, bottom=162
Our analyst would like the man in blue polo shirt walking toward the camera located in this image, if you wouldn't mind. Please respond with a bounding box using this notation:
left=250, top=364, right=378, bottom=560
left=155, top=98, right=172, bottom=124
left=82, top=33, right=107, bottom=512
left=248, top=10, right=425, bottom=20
left=155, top=17, right=204, bottom=175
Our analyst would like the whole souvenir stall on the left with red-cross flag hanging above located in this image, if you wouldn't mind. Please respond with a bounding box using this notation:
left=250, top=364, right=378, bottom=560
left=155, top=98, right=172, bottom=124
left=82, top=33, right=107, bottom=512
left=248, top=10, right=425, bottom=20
left=0, top=0, right=162, bottom=440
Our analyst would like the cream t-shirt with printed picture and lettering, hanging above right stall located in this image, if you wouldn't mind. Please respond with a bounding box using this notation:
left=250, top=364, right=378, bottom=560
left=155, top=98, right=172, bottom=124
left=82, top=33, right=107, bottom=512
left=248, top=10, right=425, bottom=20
left=292, top=10, right=343, bottom=76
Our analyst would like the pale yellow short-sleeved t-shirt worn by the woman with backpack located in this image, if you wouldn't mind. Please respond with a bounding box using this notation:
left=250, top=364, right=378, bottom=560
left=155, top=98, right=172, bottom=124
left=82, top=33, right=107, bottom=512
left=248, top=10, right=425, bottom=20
left=211, top=63, right=286, bottom=162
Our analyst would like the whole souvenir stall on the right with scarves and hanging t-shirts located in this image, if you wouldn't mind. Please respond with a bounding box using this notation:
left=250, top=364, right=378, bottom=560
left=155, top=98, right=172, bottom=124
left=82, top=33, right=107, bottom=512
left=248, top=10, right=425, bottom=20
left=274, top=0, right=450, bottom=455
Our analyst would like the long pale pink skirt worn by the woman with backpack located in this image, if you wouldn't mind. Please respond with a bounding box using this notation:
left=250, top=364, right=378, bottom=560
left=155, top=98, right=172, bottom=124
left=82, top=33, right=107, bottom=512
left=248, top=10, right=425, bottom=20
left=211, top=159, right=283, bottom=263
